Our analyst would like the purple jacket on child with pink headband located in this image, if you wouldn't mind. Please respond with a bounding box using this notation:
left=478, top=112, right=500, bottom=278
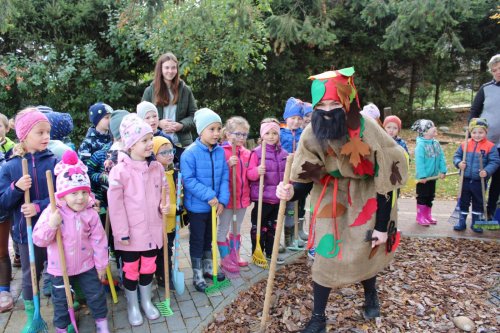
left=247, top=145, right=288, bottom=204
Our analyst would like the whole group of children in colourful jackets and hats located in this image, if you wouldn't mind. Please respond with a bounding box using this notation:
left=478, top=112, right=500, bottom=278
left=0, top=97, right=500, bottom=332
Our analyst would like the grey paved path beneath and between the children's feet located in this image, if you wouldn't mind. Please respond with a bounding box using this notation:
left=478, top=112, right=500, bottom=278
left=0, top=199, right=500, bottom=333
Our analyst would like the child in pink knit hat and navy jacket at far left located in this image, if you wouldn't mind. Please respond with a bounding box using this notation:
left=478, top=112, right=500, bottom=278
left=0, top=108, right=57, bottom=333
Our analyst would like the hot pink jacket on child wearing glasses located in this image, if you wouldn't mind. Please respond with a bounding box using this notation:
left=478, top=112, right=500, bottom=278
left=222, top=143, right=251, bottom=209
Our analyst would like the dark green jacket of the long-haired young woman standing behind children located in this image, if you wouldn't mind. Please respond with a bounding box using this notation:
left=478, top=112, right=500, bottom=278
left=142, top=80, right=198, bottom=147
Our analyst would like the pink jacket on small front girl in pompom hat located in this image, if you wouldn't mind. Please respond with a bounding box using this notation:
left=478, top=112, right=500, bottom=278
left=33, top=199, right=108, bottom=276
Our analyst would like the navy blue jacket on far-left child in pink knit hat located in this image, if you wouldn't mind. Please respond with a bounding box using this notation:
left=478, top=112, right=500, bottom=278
left=0, top=149, right=57, bottom=244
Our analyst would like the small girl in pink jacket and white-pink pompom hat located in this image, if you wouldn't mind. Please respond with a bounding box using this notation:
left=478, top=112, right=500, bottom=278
left=33, top=150, right=109, bottom=333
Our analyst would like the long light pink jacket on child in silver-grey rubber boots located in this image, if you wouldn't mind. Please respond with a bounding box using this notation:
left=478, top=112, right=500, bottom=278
left=108, top=153, right=169, bottom=251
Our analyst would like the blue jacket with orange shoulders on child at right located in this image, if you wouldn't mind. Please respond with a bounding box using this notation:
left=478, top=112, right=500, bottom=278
left=453, top=139, right=500, bottom=180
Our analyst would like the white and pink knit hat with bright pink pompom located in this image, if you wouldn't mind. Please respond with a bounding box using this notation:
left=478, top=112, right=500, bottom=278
left=54, top=150, right=90, bottom=199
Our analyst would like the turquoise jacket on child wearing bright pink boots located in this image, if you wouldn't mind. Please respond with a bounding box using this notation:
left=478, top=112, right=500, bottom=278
left=415, top=136, right=447, bottom=179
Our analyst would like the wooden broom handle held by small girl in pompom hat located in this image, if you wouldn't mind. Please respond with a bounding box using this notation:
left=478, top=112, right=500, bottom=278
left=45, top=170, right=78, bottom=333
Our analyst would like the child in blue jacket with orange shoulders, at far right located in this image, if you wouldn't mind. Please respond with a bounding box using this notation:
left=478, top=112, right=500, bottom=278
left=453, top=118, right=500, bottom=233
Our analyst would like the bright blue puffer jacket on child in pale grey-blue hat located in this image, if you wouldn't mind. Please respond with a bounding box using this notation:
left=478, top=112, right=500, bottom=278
left=181, top=138, right=229, bottom=213
